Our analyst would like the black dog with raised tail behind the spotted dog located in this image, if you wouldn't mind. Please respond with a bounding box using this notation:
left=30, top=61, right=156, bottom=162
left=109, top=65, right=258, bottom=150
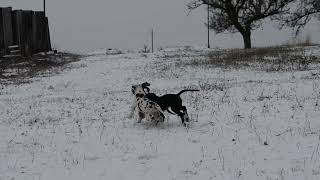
left=145, top=89, right=199, bottom=125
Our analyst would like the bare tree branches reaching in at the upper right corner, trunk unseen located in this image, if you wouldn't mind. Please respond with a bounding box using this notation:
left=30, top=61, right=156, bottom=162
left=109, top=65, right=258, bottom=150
left=278, top=0, right=320, bottom=35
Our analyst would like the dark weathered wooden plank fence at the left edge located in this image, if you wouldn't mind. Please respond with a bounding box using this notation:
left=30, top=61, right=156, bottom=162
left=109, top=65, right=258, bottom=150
left=0, top=7, right=51, bottom=56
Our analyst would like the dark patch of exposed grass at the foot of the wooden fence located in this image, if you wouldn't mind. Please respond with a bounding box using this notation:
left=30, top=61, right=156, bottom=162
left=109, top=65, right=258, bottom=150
left=0, top=53, right=81, bottom=84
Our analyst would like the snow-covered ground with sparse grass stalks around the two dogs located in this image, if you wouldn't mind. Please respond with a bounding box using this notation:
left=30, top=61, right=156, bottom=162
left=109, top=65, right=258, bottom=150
left=0, top=48, right=320, bottom=180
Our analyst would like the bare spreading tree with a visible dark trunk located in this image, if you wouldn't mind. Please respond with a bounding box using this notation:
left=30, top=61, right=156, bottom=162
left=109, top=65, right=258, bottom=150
left=188, top=0, right=296, bottom=48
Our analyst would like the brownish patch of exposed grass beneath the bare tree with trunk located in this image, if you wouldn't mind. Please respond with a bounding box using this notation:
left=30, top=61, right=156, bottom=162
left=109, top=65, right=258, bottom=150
left=180, top=46, right=320, bottom=71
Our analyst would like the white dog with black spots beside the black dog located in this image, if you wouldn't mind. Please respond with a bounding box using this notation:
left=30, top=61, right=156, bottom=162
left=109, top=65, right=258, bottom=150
left=131, top=82, right=165, bottom=124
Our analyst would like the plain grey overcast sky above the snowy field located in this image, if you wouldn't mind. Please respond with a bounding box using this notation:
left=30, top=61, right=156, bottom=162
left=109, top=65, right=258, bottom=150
left=0, top=0, right=320, bottom=52
